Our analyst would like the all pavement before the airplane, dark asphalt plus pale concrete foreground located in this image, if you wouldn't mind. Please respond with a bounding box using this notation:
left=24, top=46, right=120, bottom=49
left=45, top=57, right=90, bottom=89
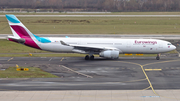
left=0, top=56, right=180, bottom=101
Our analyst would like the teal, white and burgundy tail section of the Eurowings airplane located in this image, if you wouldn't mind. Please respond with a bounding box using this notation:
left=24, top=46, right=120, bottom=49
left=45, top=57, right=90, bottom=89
left=6, top=15, right=41, bottom=49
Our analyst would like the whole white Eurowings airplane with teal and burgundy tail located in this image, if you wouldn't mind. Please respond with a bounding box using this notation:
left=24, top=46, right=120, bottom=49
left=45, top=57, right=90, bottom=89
left=6, top=15, right=176, bottom=60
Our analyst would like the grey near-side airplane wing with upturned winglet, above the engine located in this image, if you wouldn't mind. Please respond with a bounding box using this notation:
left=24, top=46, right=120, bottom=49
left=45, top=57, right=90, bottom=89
left=60, top=41, right=119, bottom=54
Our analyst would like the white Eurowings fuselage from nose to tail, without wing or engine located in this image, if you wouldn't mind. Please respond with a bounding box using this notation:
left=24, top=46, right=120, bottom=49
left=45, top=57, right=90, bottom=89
left=36, top=38, right=176, bottom=54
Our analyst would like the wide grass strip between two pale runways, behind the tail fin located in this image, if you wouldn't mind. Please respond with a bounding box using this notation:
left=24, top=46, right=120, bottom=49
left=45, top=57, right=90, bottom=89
left=0, top=17, right=180, bottom=34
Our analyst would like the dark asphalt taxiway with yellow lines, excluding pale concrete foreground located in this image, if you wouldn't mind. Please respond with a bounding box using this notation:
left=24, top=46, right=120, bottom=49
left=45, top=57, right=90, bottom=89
left=0, top=57, right=180, bottom=91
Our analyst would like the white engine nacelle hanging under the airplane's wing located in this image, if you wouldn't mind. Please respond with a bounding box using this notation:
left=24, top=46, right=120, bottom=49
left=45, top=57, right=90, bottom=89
left=99, top=50, right=119, bottom=59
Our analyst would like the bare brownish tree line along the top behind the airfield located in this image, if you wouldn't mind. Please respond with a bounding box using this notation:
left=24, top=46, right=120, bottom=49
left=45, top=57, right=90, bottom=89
left=0, top=0, right=180, bottom=12
